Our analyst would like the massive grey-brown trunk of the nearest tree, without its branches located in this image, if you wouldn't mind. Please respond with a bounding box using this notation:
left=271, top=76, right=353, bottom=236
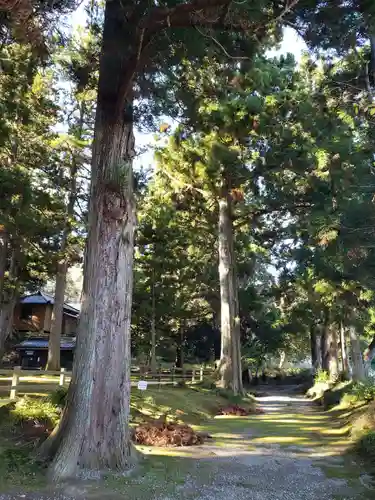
left=43, top=0, right=135, bottom=480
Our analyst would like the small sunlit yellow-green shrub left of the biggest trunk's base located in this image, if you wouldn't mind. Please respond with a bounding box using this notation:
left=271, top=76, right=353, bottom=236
left=10, top=396, right=61, bottom=426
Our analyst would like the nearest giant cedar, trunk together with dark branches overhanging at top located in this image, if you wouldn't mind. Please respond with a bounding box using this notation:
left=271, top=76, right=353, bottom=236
left=46, top=0, right=304, bottom=479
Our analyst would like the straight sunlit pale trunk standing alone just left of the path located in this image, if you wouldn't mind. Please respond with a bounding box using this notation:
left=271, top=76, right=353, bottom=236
left=218, top=189, right=243, bottom=394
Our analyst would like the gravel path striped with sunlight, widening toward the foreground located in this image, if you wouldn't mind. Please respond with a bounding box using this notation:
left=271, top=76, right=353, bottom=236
left=0, top=391, right=375, bottom=500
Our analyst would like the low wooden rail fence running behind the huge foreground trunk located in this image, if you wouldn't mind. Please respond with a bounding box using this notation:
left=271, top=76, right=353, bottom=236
left=0, top=366, right=212, bottom=400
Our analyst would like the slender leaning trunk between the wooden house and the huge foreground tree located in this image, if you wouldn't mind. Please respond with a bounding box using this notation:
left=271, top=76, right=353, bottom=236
left=46, top=107, right=84, bottom=371
